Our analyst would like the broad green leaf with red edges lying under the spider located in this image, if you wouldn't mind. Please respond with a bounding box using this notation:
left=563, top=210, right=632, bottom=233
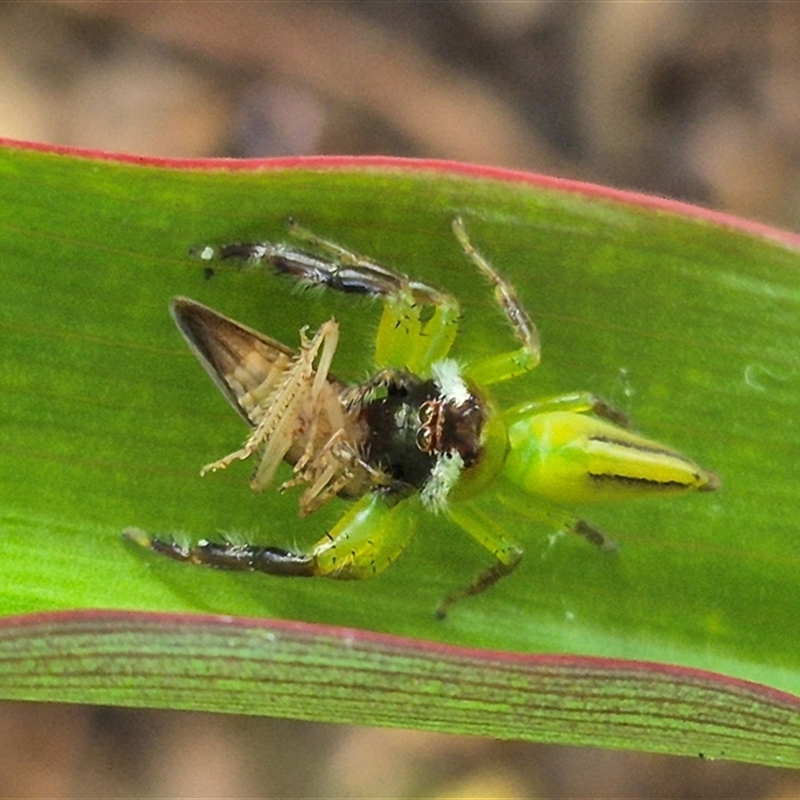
left=0, top=141, right=800, bottom=765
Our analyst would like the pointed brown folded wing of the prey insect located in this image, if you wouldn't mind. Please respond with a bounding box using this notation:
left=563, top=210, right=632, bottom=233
left=170, top=297, right=297, bottom=425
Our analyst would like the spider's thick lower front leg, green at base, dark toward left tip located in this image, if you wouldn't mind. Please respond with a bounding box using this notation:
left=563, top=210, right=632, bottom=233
left=125, top=493, right=419, bottom=580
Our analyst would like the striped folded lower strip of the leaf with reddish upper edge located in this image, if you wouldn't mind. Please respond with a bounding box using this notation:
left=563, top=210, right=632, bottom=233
left=0, top=612, right=800, bottom=767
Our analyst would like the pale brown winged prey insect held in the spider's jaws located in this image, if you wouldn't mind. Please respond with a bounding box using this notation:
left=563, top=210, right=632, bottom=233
left=171, top=304, right=373, bottom=516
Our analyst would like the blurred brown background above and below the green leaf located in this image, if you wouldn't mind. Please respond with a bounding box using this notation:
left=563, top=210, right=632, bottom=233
left=0, top=0, right=800, bottom=798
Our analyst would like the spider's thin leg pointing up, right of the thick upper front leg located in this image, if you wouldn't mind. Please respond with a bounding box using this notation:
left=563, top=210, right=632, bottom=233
left=453, top=217, right=541, bottom=386
